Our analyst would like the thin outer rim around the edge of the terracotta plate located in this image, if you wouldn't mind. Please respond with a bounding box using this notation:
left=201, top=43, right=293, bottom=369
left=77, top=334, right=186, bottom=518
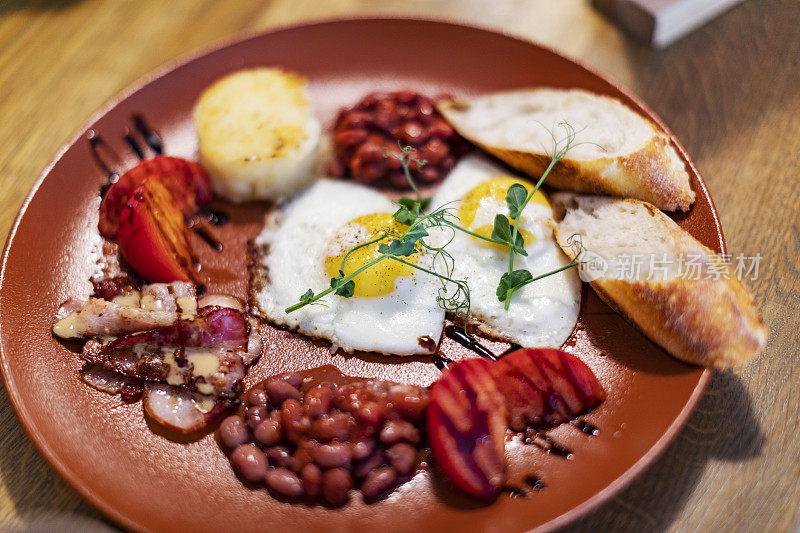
left=0, top=15, right=712, bottom=532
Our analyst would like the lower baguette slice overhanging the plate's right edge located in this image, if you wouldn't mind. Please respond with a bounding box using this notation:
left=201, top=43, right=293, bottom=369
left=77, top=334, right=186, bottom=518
left=553, top=193, right=767, bottom=367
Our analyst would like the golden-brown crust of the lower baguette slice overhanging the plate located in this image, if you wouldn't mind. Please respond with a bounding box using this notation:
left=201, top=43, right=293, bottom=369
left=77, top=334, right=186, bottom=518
left=555, top=194, right=767, bottom=368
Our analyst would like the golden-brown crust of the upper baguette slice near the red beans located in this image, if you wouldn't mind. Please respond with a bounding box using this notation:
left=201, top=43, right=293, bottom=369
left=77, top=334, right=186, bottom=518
left=437, top=100, right=695, bottom=211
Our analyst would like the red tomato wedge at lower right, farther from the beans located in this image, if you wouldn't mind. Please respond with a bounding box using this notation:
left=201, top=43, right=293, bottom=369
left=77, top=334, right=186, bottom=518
left=491, top=348, right=606, bottom=431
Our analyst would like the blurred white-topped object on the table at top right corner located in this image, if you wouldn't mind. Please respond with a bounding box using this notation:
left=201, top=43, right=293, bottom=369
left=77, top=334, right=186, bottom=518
left=592, top=0, right=742, bottom=48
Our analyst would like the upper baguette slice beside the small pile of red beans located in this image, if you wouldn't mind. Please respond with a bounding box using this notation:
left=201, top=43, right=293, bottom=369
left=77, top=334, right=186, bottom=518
left=438, top=89, right=695, bottom=211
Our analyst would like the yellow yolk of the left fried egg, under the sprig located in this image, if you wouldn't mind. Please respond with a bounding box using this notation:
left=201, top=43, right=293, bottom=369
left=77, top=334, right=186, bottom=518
left=325, top=213, right=417, bottom=297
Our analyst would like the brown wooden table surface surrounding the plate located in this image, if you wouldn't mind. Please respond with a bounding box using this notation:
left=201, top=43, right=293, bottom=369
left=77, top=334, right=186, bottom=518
left=0, top=0, right=800, bottom=531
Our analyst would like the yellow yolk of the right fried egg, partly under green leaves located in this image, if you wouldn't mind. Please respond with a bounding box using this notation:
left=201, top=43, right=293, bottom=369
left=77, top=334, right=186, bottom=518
left=458, top=176, right=552, bottom=251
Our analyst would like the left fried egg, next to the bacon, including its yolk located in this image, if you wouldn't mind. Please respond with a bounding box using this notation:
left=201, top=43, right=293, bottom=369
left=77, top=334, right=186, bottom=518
left=255, top=179, right=444, bottom=355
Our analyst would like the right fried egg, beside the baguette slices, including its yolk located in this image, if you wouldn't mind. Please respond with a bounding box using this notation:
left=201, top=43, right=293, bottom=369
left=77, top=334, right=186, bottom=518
left=432, top=156, right=581, bottom=348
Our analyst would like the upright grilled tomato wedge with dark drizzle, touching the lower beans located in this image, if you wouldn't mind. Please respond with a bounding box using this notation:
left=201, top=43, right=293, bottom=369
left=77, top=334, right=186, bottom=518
left=428, top=359, right=506, bottom=499
